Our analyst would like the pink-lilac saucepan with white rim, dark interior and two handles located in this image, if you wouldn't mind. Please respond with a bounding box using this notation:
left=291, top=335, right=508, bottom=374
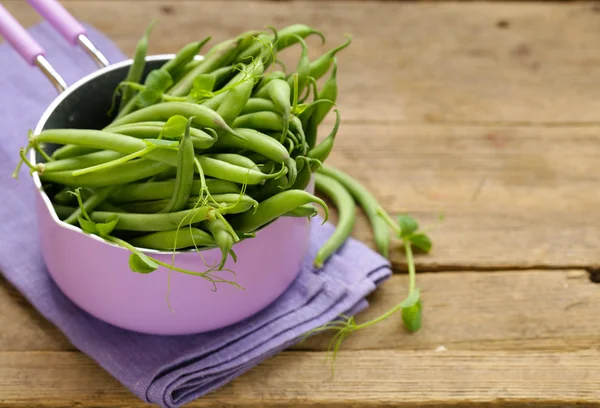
left=0, top=0, right=312, bottom=335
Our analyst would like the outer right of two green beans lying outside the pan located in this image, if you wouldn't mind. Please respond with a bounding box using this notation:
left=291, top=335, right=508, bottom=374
left=319, top=165, right=390, bottom=258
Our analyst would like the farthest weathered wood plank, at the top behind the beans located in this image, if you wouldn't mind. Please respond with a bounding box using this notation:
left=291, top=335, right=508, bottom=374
left=4, top=0, right=600, bottom=123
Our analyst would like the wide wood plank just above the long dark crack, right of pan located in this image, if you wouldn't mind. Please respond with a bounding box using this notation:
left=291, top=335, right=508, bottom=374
left=323, top=125, right=600, bottom=270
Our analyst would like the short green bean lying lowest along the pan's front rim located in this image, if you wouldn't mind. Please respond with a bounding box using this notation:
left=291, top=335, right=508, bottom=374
left=129, top=227, right=217, bottom=251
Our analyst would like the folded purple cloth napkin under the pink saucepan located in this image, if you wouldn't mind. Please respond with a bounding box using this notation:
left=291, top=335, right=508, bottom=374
left=0, top=22, right=391, bottom=407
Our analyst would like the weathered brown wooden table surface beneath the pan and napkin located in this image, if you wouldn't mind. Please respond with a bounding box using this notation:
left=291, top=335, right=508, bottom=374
left=0, top=0, right=600, bottom=407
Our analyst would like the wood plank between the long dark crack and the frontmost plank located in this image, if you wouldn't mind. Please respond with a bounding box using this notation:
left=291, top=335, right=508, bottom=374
left=0, top=270, right=600, bottom=351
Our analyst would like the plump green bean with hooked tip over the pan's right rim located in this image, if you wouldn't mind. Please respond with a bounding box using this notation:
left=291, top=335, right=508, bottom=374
left=230, top=190, right=329, bottom=232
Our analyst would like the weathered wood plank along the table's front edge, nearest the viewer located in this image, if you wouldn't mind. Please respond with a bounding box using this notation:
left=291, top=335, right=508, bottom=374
left=0, top=350, right=600, bottom=408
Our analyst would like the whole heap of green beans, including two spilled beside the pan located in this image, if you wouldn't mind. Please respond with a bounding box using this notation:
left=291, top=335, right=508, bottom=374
left=16, top=24, right=390, bottom=280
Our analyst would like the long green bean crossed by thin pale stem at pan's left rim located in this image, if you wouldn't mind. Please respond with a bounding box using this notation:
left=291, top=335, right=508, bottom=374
left=40, top=159, right=170, bottom=188
